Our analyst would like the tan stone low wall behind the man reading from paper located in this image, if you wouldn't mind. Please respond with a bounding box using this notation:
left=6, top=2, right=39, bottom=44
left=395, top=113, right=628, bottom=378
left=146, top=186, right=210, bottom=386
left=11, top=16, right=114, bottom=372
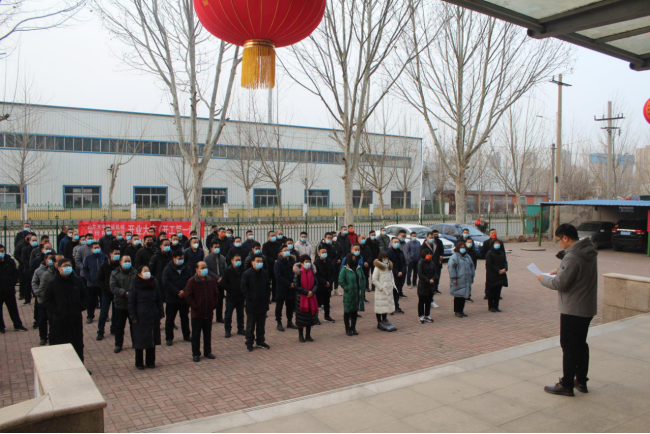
left=603, top=273, right=650, bottom=323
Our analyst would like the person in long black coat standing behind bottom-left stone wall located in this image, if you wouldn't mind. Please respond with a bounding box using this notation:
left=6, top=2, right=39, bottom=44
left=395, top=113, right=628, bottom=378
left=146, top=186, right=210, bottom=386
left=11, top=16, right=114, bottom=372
left=43, top=258, right=88, bottom=363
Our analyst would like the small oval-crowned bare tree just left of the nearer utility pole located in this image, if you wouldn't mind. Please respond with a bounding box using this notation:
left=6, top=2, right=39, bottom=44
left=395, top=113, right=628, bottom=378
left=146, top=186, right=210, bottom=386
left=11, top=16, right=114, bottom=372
left=490, top=100, right=548, bottom=228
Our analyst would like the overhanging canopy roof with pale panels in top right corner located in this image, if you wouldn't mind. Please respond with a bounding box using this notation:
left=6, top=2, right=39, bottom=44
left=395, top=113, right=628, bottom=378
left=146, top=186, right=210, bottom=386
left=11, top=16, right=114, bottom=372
left=444, top=0, right=650, bottom=71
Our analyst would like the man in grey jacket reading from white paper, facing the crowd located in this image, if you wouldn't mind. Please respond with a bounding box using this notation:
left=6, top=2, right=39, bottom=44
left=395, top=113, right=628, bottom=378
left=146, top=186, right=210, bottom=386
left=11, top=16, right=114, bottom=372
left=537, top=223, right=598, bottom=396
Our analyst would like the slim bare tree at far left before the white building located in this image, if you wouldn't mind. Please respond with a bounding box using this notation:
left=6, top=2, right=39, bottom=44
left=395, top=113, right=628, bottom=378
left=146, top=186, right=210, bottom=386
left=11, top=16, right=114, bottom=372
left=2, top=80, right=53, bottom=221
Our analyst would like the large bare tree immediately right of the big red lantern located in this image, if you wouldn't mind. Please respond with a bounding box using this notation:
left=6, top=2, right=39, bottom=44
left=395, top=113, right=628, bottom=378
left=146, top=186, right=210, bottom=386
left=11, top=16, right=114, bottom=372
left=283, top=0, right=420, bottom=223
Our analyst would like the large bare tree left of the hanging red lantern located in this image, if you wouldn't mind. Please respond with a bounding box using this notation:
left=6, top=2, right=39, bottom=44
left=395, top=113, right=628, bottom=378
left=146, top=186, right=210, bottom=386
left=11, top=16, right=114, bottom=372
left=99, top=0, right=241, bottom=229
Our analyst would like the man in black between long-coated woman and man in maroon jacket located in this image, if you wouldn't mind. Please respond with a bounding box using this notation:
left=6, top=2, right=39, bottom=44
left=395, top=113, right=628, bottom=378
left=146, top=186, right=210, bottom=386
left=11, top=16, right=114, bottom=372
left=162, top=252, right=193, bottom=346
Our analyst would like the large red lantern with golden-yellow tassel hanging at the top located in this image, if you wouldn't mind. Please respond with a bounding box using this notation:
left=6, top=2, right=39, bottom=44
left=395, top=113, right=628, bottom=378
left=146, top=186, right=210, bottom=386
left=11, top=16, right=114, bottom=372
left=194, top=0, right=325, bottom=89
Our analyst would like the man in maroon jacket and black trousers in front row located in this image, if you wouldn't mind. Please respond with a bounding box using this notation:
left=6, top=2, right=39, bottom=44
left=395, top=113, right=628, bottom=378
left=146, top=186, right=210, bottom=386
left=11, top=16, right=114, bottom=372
left=184, top=261, right=219, bottom=362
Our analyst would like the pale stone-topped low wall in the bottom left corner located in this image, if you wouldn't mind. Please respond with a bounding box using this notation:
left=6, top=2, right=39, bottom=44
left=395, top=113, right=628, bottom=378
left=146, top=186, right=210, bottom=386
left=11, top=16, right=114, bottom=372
left=0, top=344, right=106, bottom=432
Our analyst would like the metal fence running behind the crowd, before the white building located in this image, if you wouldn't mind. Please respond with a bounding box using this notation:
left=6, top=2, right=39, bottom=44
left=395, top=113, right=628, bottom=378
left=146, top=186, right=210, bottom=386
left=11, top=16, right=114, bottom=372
left=0, top=214, right=538, bottom=254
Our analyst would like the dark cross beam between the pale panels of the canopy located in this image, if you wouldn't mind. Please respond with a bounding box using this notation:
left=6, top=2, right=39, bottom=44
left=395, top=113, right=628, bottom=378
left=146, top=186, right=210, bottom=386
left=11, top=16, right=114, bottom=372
left=528, top=0, right=650, bottom=38
